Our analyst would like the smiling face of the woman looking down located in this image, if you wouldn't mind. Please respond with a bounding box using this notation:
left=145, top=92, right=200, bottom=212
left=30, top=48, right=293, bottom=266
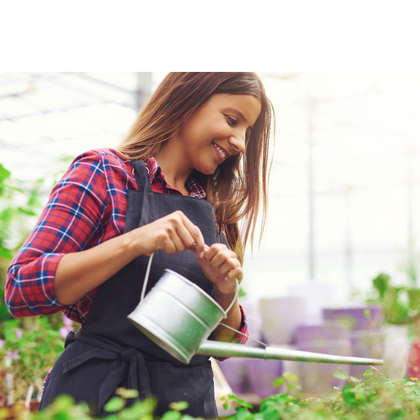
left=172, top=94, right=261, bottom=175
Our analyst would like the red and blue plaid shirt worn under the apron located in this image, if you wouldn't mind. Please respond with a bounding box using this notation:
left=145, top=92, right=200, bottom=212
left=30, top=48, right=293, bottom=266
left=5, top=149, right=248, bottom=343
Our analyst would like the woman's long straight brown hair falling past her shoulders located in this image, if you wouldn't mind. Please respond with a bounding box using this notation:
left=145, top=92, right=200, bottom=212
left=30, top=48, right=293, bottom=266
left=117, top=72, right=274, bottom=260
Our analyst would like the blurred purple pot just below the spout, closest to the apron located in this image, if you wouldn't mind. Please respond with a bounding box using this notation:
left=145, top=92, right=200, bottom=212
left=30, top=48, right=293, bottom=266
left=247, top=359, right=283, bottom=397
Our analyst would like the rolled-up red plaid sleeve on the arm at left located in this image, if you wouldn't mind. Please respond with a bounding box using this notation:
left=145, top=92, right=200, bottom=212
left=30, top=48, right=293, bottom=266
left=5, top=152, right=113, bottom=322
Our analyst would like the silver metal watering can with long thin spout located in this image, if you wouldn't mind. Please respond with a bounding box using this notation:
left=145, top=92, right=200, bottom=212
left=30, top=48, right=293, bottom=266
left=128, top=254, right=384, bottom=365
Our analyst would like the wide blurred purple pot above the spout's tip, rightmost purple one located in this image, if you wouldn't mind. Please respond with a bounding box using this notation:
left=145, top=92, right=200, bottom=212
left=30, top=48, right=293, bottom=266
left=323, top=306, right=384, bottom=330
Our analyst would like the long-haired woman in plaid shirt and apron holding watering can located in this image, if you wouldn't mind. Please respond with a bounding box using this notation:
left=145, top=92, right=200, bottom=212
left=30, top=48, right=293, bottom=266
left=5, top=73, right=272, bottom=418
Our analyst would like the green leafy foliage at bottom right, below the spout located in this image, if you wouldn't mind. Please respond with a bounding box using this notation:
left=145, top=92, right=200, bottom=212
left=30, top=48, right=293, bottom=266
left=225, top=367, right=420, bottom=420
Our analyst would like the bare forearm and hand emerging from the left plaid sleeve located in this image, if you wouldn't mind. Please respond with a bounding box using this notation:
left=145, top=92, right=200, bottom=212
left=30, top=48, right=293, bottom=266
left=54, top=211, right=205, bottom=305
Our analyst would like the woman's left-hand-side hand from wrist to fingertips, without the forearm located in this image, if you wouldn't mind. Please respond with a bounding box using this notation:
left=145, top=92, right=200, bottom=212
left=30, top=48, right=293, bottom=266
left=127, top=210, right=205, bottom=257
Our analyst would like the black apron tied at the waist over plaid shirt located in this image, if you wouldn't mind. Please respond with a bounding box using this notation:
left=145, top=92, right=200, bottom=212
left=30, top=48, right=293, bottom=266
left=40, top=161, right=224, bottom=418
